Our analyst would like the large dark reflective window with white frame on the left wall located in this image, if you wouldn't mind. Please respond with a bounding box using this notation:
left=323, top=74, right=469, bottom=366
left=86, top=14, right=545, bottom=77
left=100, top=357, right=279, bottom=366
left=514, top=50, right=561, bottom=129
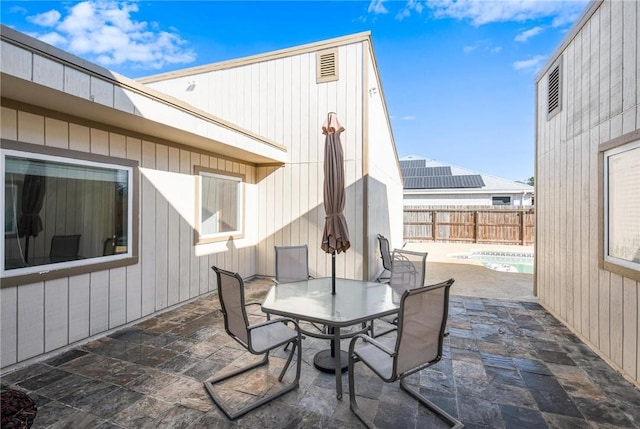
left=0, top=147, right=133, bottom=284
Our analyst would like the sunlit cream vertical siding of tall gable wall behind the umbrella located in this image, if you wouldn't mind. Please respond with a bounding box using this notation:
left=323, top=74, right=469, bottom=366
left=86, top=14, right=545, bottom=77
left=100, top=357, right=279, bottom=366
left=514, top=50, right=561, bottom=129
left=140, top=42, right=370, bottom=278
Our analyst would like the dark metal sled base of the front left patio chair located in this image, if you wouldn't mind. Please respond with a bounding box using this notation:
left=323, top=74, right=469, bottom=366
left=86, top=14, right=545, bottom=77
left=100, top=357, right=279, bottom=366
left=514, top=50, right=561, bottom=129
left=204, top=336, right=302, bottom=420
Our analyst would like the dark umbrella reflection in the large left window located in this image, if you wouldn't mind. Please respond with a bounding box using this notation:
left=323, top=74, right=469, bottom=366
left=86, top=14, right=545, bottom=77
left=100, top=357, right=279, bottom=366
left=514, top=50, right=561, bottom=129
left=18, top=165, right=46, bottom=262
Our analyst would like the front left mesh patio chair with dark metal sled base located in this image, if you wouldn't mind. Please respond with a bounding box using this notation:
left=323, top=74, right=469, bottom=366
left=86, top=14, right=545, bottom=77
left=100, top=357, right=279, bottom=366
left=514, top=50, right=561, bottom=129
left=204, top=266, right=302, bottom=420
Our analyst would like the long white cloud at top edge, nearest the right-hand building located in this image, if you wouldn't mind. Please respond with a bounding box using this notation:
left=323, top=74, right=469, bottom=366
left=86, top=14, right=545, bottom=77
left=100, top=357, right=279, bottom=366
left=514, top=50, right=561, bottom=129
left=425, top=0, right=587, bottom=26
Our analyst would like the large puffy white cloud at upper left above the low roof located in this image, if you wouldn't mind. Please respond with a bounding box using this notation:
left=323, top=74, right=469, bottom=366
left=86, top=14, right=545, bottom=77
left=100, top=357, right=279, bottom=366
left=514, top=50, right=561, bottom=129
left=28, top=0, right=196, bottom=69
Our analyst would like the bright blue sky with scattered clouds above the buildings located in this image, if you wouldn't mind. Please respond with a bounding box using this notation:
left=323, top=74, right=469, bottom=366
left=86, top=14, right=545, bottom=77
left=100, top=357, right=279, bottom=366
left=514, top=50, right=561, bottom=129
left=0, top=0, right=587, bottom=180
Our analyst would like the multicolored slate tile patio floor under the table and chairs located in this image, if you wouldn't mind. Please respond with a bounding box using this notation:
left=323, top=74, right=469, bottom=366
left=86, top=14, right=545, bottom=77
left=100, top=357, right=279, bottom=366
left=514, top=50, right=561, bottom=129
left=1, top=281, right=640, bottom=429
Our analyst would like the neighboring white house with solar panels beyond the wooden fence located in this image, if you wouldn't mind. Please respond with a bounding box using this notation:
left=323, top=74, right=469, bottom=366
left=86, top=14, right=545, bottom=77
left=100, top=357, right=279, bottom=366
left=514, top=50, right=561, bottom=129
left=400, top=155, right=534, bottom=207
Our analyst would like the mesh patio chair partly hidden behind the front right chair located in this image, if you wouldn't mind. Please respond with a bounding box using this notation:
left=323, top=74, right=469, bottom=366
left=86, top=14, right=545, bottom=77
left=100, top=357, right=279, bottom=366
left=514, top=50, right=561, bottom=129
left=370, top=249, right=427, bottom=338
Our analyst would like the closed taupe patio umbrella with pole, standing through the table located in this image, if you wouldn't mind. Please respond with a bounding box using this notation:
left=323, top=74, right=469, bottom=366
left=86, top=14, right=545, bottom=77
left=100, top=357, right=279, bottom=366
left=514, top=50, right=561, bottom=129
left=321, top=112, right=351, bottom=295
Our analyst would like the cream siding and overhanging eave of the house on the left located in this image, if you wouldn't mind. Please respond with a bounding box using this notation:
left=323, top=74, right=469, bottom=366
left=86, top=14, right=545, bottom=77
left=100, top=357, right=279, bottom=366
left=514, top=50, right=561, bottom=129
left=0, top=26, right=402, bottom=368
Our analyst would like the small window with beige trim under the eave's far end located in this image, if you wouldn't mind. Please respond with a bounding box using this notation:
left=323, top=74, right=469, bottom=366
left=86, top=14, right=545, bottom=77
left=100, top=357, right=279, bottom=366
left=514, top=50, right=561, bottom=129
left=197, top=169, right=244, bottom=242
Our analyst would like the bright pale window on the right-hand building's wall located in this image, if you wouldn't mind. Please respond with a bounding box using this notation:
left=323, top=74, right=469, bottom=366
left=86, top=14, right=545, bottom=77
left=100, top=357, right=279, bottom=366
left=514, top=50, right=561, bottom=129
left=602, top=135, right=640, bottom=278
